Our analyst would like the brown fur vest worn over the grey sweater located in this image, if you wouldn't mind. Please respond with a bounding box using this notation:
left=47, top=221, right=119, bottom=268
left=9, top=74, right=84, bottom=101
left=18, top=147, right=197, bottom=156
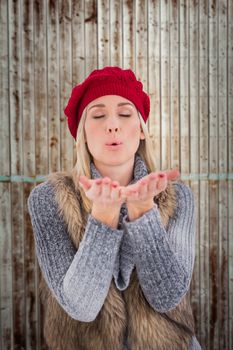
left=40, top=172, right=194, bottom=350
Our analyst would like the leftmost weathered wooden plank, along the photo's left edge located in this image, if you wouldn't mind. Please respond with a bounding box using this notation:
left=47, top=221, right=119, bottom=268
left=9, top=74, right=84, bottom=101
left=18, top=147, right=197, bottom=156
left=0, top=1, right=10, bottom=349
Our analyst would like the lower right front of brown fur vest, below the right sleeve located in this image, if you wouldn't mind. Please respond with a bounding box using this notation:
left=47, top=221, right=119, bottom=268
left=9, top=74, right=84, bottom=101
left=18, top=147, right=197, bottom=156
left=124, top=270, right=192, bottom=350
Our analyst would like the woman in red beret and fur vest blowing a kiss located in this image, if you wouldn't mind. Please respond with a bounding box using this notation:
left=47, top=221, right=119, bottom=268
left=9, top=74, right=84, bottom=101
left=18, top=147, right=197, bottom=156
left=28, top=67, right=200, bottom=350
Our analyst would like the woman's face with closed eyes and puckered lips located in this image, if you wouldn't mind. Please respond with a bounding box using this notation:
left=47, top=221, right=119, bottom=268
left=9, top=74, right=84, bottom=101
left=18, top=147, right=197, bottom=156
left=84, top=95, right=145, bottom=165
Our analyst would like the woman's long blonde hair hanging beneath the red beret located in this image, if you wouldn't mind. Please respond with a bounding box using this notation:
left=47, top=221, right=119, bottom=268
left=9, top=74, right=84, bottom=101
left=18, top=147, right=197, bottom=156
left=72, top=108, right=156, bottom=212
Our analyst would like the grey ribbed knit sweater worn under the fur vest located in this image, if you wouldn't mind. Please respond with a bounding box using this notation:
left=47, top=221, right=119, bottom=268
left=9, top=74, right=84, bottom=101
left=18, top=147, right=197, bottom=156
left=28, top=155, right=201, bottom=350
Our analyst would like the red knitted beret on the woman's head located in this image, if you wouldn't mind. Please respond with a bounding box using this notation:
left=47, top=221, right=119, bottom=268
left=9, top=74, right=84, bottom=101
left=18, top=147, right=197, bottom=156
left=64, top=67, right=150, bottom=140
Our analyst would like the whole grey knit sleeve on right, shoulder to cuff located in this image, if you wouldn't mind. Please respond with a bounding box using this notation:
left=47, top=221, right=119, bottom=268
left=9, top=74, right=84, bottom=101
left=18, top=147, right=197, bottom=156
left=123, top=183, right=195, bottom=312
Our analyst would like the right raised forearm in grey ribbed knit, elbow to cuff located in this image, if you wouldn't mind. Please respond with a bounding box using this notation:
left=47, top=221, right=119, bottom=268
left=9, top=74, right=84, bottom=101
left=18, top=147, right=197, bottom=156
left=124, top=205, right=189, bottom=312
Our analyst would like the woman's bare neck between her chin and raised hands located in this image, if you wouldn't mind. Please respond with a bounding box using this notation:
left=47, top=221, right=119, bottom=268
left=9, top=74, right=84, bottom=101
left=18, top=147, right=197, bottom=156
left=94, top=157, right=134, bottom=186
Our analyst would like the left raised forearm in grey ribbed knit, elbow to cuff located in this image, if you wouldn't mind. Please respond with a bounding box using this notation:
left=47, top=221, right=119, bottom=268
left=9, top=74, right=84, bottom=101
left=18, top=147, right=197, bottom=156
left=63, top=213, right=123, bottom=322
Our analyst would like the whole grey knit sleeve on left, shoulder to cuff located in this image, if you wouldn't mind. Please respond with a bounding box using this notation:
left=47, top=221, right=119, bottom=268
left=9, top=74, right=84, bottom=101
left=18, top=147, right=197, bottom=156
left=28, top=182, right=123, bottom=322
